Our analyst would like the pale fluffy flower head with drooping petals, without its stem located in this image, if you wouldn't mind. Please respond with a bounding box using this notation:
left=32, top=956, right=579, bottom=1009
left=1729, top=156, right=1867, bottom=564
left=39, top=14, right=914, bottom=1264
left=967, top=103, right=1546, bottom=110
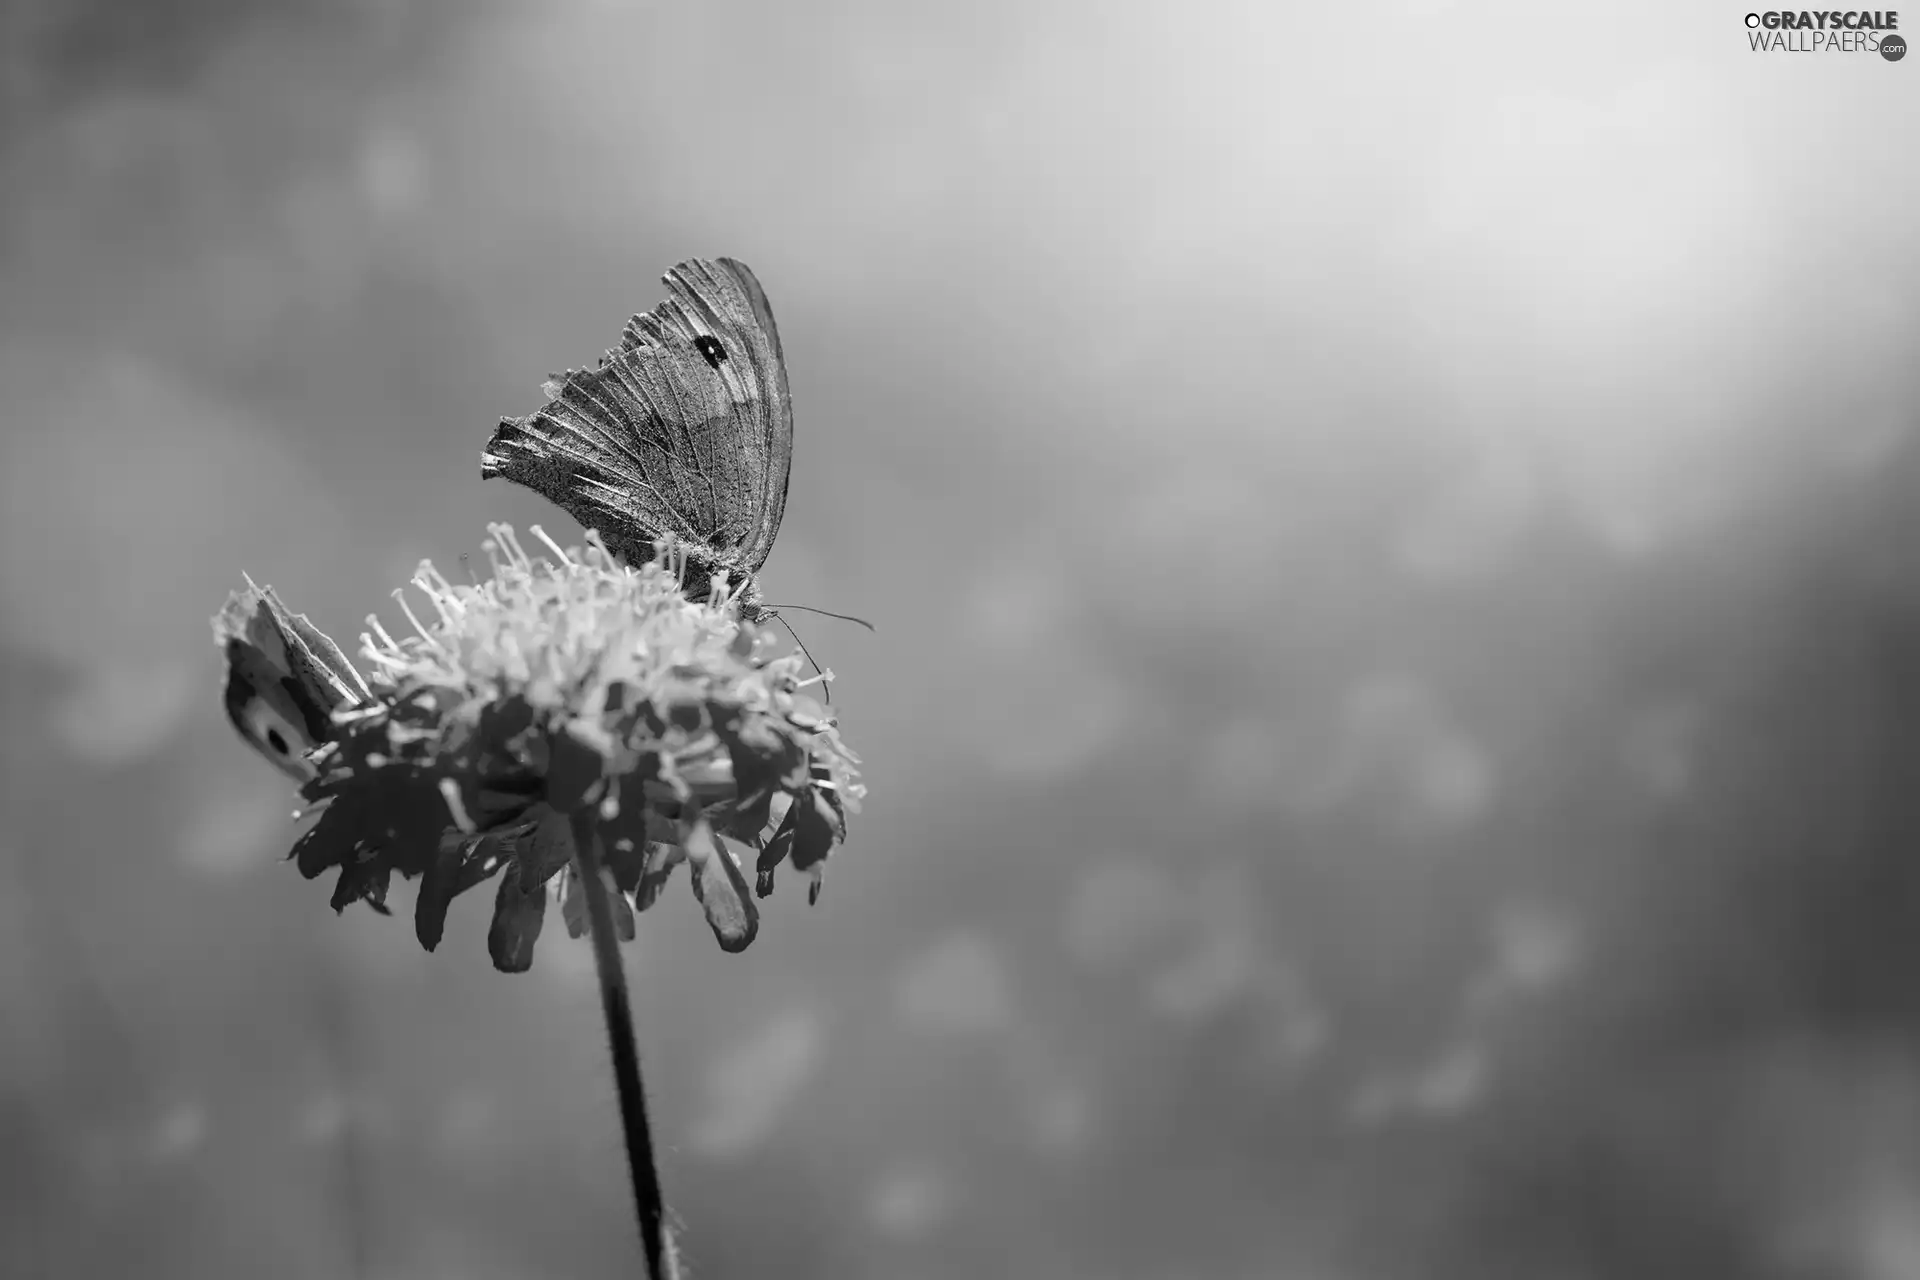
left=215, top=526, right=864, bottom=971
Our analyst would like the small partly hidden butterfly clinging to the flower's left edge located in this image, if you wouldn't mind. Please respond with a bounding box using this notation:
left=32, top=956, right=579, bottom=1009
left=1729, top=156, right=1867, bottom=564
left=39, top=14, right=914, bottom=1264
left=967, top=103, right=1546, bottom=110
left=213, top=578, right=372, bottom=783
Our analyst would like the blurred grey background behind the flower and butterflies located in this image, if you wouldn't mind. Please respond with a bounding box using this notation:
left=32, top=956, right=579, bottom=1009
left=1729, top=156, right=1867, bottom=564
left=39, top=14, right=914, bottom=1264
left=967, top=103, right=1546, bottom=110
left=0, top=0, right=1920, bottom=1280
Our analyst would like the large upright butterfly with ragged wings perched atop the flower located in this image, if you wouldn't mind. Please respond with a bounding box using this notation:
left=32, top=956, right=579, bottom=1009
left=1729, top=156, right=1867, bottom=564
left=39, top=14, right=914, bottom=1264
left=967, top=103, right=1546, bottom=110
left=480, top=257, right=793, bottom=622
